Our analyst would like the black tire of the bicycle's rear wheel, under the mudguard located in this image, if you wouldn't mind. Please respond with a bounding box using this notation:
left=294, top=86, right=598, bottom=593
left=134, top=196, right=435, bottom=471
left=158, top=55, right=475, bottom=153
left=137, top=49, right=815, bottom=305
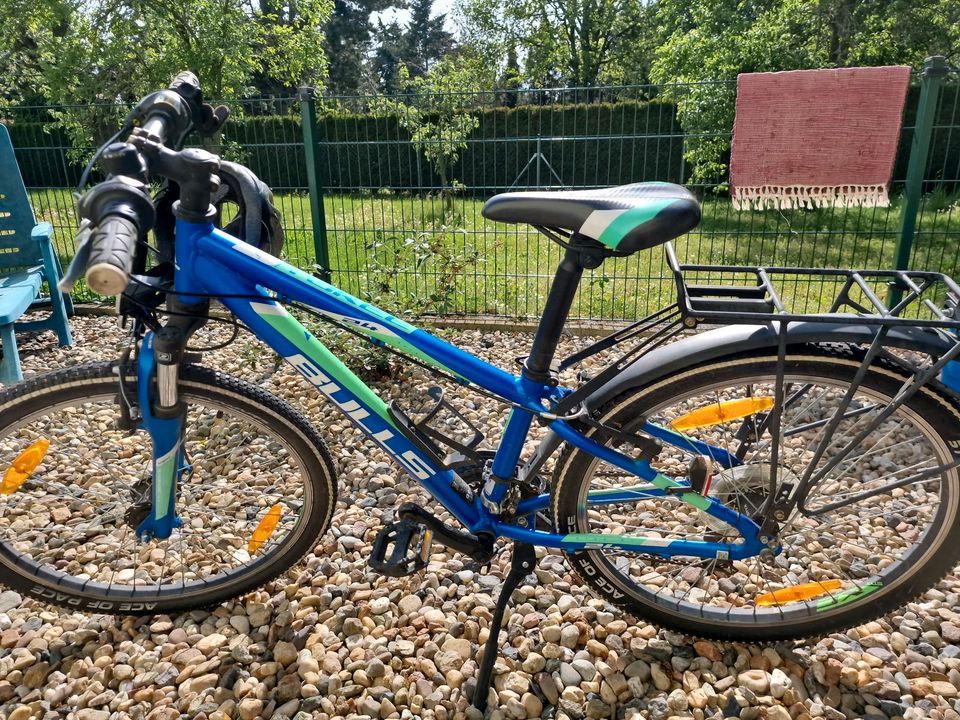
left=551, top=346, right=960, bottom=641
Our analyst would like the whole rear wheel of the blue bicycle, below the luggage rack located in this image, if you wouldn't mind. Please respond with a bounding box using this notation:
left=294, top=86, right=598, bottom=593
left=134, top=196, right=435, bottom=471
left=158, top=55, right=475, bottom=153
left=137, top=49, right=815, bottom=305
left=552, top=346, right=960, bottom=640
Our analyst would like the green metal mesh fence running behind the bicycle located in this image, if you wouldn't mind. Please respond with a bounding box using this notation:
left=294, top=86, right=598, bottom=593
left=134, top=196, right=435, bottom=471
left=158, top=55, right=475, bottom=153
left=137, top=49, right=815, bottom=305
left=4, top=63, right=960, bottom=321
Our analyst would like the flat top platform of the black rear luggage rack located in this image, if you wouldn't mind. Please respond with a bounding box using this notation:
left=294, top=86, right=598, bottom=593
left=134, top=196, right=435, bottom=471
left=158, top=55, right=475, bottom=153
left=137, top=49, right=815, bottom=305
left=664, top=243, right=960, bottom=330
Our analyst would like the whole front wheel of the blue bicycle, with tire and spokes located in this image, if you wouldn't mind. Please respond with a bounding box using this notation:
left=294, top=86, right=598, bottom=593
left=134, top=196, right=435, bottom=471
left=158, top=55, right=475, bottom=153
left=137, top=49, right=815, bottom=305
left=0, top=363, right=336, bottom=614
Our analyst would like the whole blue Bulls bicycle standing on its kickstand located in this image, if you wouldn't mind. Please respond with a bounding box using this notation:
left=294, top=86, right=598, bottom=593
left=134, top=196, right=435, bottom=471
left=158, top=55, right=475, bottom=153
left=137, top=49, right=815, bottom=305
left=0, top=74, right=960, bottom=700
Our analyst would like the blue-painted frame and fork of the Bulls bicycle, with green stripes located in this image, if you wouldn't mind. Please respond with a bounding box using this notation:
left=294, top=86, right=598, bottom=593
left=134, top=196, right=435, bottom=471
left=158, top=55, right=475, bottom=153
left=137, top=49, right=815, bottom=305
left=138, top=219, right=766, bottom=560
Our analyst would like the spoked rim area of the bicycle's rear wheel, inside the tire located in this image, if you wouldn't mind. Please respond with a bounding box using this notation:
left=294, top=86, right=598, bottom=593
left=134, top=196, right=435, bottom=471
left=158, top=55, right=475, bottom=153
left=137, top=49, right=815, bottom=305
left=577, top=368, right=957, bottom=625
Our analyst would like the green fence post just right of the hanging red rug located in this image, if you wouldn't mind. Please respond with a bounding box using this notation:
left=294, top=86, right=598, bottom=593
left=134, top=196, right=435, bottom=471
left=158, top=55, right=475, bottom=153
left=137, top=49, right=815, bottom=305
left=888, top=55, right=947, bottom=305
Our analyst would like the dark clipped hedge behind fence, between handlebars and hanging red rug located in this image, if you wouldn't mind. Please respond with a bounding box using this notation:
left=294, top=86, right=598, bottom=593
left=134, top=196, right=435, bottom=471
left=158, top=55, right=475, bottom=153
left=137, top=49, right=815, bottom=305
left=221, top=102, right=683, bottom=195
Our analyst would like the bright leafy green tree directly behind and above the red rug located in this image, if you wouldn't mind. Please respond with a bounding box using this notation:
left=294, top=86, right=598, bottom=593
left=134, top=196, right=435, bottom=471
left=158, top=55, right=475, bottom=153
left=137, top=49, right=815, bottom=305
left=651, top=0, right=960, bottom=183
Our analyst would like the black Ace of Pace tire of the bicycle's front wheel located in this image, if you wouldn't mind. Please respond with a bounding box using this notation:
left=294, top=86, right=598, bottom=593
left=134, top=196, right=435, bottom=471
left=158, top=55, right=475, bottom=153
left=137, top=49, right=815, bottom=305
left=0, top=363, right=336, bottom=615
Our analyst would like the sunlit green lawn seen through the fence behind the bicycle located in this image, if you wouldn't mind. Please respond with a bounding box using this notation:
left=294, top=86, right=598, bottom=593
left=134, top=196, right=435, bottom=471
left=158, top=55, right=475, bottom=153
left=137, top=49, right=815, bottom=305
left=32, top=190, right=960, bottom=320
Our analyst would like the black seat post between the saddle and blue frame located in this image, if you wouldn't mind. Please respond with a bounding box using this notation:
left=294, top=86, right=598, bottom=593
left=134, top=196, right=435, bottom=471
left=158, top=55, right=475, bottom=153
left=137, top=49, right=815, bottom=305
left=523, top=244, right=602, bottom=385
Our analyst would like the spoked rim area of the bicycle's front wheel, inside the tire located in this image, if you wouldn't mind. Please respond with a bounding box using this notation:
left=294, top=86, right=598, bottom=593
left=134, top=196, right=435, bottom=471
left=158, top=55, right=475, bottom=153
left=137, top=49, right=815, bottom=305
left=0, top=380, right=315, bottom=609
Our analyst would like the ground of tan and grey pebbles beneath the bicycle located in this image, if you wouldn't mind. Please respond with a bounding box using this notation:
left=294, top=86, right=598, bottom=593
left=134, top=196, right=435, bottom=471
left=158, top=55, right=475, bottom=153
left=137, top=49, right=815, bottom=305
left=0, top=317, right=960, bottom=720
